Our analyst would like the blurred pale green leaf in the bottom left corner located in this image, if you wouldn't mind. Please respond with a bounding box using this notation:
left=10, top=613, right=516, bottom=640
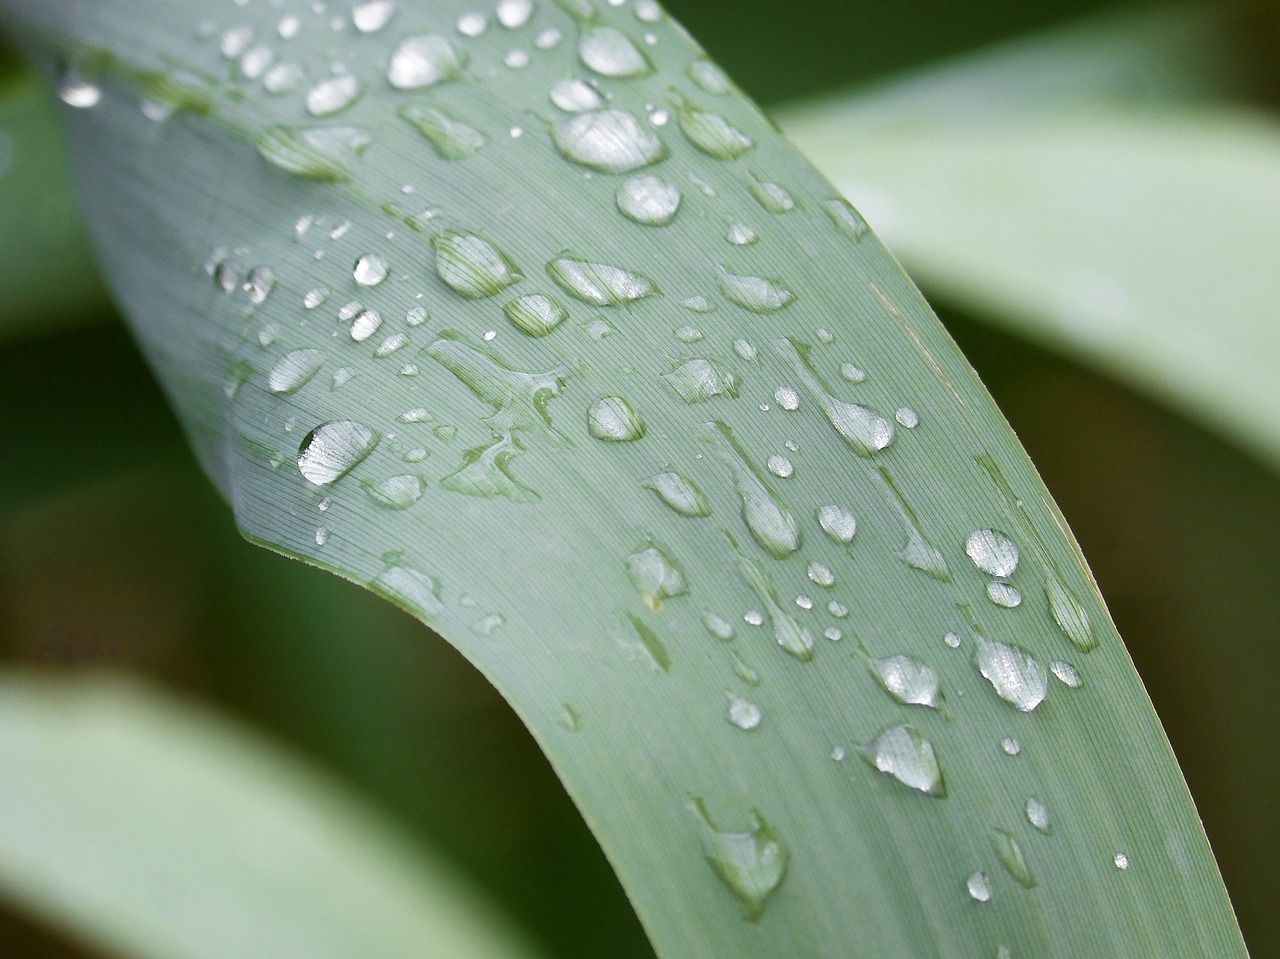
left=0, top=672, right=545, bottom=959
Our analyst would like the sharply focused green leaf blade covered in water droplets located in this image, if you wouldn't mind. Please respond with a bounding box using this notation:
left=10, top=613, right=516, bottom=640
left=4, top=0, right=1243, bottom=958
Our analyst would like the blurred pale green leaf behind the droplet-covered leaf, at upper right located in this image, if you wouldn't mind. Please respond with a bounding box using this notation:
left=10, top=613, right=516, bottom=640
left=782, top=6, right=1280, bottom=466
